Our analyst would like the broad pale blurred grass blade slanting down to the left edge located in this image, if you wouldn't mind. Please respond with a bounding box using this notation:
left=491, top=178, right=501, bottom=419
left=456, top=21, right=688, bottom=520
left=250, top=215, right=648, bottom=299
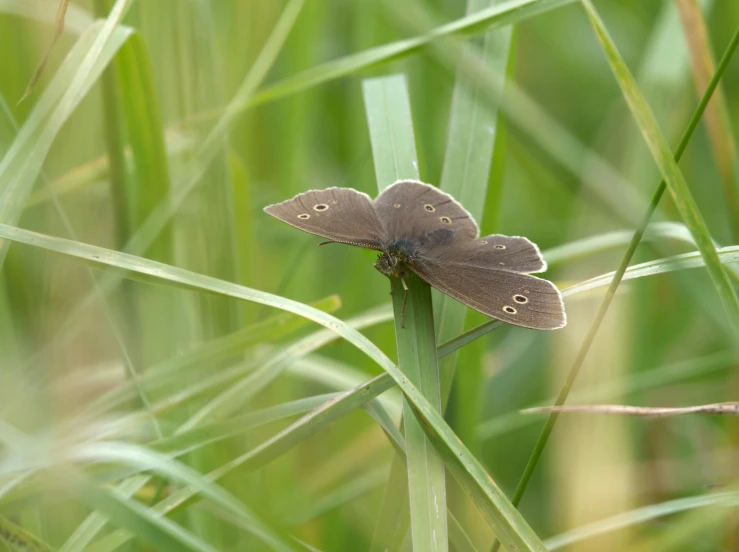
left=0, top=0, right=131, bottom=266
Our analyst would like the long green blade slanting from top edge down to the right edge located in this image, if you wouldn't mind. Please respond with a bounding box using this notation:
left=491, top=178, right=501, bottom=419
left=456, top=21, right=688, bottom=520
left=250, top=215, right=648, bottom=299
left=582, top=0, right=739, bottom=335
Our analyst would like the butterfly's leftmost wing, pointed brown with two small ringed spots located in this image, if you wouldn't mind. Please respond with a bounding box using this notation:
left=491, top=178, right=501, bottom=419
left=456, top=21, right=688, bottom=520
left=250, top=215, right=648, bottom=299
left=264, top=188, right=384, bottom=249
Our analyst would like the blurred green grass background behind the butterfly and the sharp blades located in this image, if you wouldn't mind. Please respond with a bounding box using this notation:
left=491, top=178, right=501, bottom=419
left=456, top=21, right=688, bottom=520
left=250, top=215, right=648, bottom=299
left=0, top=0, right=739, bottom=551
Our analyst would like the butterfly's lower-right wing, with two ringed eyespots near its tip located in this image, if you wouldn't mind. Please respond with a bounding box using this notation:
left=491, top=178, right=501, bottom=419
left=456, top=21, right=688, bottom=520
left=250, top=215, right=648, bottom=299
left=410, top=258, right=567, bottom=330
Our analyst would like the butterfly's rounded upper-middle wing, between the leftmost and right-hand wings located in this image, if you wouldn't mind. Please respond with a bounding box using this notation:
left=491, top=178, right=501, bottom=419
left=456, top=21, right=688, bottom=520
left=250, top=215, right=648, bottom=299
left=375, top=180, right=479, bottom=244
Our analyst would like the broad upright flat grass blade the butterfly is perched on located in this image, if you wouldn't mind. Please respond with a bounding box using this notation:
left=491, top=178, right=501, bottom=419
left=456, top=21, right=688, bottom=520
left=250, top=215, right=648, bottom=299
left=363, top=75, right=449, bottom=551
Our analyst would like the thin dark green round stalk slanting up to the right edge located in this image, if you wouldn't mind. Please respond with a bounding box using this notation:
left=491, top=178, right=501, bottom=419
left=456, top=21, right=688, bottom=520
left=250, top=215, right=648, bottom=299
left=491, top=19, right=739, bottom=552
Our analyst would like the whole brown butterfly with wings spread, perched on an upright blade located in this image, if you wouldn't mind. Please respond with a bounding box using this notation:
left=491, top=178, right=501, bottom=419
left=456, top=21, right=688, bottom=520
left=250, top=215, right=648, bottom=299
left=264, top=180, right=567, bottom=330
